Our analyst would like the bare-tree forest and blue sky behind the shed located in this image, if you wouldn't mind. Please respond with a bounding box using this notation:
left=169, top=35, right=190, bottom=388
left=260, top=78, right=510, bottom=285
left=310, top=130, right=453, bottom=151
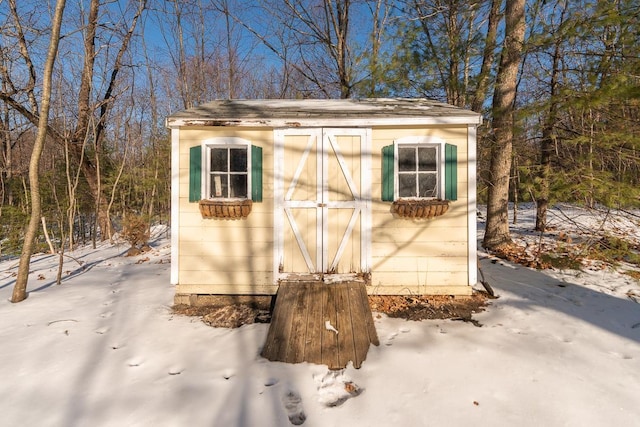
left=0, top=0, right=640, bottom=264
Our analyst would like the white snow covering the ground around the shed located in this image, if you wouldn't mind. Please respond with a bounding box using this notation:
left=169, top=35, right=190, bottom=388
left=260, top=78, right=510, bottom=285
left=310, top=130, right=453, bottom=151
left=0, top=206, right=640, bottom=427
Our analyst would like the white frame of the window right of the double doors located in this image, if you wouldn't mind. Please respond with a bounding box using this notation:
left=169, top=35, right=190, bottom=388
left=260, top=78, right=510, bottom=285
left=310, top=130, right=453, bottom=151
left=393, top=136, right=445, bottom=200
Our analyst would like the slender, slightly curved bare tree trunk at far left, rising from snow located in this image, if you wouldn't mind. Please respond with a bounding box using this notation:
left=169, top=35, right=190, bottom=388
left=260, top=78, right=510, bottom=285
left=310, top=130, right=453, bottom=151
left=11, top=0, right=65, bottom=303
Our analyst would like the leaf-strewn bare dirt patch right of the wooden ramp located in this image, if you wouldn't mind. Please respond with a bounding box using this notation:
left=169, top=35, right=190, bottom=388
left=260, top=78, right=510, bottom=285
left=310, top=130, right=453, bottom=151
left=369, top=292, right=490, bottom=326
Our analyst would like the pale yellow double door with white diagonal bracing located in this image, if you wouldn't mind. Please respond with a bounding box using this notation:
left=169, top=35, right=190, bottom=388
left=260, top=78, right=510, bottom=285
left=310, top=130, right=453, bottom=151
left=274, top=128, right=371, bottom=281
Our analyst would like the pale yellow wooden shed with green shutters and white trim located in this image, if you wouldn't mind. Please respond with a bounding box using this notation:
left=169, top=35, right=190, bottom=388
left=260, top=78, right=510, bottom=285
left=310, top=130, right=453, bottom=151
left=166, top=99, right=482, bottom=303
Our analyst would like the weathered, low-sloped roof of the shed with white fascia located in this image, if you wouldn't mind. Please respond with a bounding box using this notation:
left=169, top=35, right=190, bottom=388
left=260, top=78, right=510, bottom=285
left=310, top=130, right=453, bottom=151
left=166, top=98, right=482, bottom=128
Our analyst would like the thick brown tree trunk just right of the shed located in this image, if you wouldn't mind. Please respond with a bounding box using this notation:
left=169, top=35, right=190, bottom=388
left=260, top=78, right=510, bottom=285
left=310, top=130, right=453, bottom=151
left=483, top=0, right=525, bottom=249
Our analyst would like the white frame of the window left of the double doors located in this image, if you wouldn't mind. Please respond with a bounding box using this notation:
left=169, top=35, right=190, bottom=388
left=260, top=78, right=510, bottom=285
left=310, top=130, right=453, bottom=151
left=201, top=137, right=253, bottom=201
